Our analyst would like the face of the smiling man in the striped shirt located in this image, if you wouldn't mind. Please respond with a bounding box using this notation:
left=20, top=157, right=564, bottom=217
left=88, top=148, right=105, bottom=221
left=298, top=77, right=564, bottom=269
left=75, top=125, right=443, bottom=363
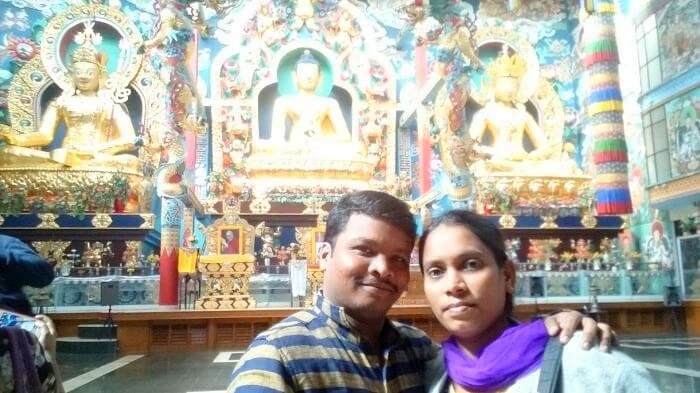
left=324, top=214, right=414, bottom=320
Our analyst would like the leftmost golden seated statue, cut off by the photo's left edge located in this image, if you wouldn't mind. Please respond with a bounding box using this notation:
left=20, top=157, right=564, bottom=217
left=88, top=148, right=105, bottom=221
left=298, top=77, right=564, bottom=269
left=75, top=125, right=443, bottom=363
left=0, top=37, right=139, bottom=171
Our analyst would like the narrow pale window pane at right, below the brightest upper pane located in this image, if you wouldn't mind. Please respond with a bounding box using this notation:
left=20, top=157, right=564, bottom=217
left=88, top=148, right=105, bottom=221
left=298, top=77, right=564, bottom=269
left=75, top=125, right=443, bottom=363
left=642, top=106, right=671, bottom=185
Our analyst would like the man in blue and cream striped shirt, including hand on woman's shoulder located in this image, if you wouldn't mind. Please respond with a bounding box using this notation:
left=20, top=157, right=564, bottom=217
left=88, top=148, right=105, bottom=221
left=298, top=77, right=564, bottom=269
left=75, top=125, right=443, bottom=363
left=228, top=191, right=609, bottom=393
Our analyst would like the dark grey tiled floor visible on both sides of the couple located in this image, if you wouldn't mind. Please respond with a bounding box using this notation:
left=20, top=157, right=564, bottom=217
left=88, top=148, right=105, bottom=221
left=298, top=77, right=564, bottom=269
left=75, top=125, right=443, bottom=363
left=59, top=336, right=700, bottom=393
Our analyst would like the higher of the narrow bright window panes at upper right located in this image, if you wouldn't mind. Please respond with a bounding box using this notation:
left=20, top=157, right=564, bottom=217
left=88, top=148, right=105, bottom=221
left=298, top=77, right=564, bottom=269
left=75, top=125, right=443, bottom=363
left=636, top=14, right=663, bottom=92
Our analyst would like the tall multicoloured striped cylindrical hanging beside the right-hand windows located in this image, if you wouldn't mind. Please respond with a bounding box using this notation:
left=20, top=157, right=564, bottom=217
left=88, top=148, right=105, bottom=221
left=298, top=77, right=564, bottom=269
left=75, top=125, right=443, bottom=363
left=583, top=0, right=632, bottom=215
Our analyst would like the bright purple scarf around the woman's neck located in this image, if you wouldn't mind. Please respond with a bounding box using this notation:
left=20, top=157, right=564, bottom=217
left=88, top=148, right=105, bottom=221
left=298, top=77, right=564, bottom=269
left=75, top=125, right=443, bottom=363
left=442, top=320, right=549, bottom=391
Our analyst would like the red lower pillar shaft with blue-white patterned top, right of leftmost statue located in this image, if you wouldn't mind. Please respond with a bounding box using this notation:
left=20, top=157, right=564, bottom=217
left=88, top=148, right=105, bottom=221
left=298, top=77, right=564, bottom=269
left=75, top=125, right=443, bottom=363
left=158, top=197, right=183, bottom=305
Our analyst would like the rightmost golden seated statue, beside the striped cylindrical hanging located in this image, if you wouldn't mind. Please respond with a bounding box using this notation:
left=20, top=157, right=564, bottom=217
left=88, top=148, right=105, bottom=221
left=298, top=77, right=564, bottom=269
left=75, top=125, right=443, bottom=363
left=469, top=49, right=575, bottom=172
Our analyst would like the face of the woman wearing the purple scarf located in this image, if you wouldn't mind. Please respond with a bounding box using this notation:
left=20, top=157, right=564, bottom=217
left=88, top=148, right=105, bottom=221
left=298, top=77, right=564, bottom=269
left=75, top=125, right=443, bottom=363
left=423, top=224, right=515, bottom=339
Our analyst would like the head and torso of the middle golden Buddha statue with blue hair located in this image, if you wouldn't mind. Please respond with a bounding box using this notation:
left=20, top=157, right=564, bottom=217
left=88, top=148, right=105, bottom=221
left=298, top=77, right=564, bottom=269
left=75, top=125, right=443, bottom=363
left=272, top=49, right=351, bottom=143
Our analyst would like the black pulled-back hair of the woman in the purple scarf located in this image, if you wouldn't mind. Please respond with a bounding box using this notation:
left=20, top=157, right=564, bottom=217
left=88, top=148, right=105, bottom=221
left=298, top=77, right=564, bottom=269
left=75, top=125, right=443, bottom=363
left=418, top=210, right=514, bottom=316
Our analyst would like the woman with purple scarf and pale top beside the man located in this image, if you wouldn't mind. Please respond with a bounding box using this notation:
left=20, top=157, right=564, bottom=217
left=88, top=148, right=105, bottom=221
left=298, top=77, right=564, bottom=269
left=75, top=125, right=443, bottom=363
left=418, top=210, right=658, bottom=393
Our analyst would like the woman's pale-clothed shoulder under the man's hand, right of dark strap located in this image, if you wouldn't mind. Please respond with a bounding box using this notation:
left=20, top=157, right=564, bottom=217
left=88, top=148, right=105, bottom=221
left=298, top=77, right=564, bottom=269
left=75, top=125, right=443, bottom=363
left=562, top=332, right=658, bottom=393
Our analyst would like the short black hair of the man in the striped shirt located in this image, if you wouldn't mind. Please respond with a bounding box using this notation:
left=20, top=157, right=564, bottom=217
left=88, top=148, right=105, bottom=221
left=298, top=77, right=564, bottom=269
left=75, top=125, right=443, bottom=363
left=323, top=190, right=416, bottom=246
